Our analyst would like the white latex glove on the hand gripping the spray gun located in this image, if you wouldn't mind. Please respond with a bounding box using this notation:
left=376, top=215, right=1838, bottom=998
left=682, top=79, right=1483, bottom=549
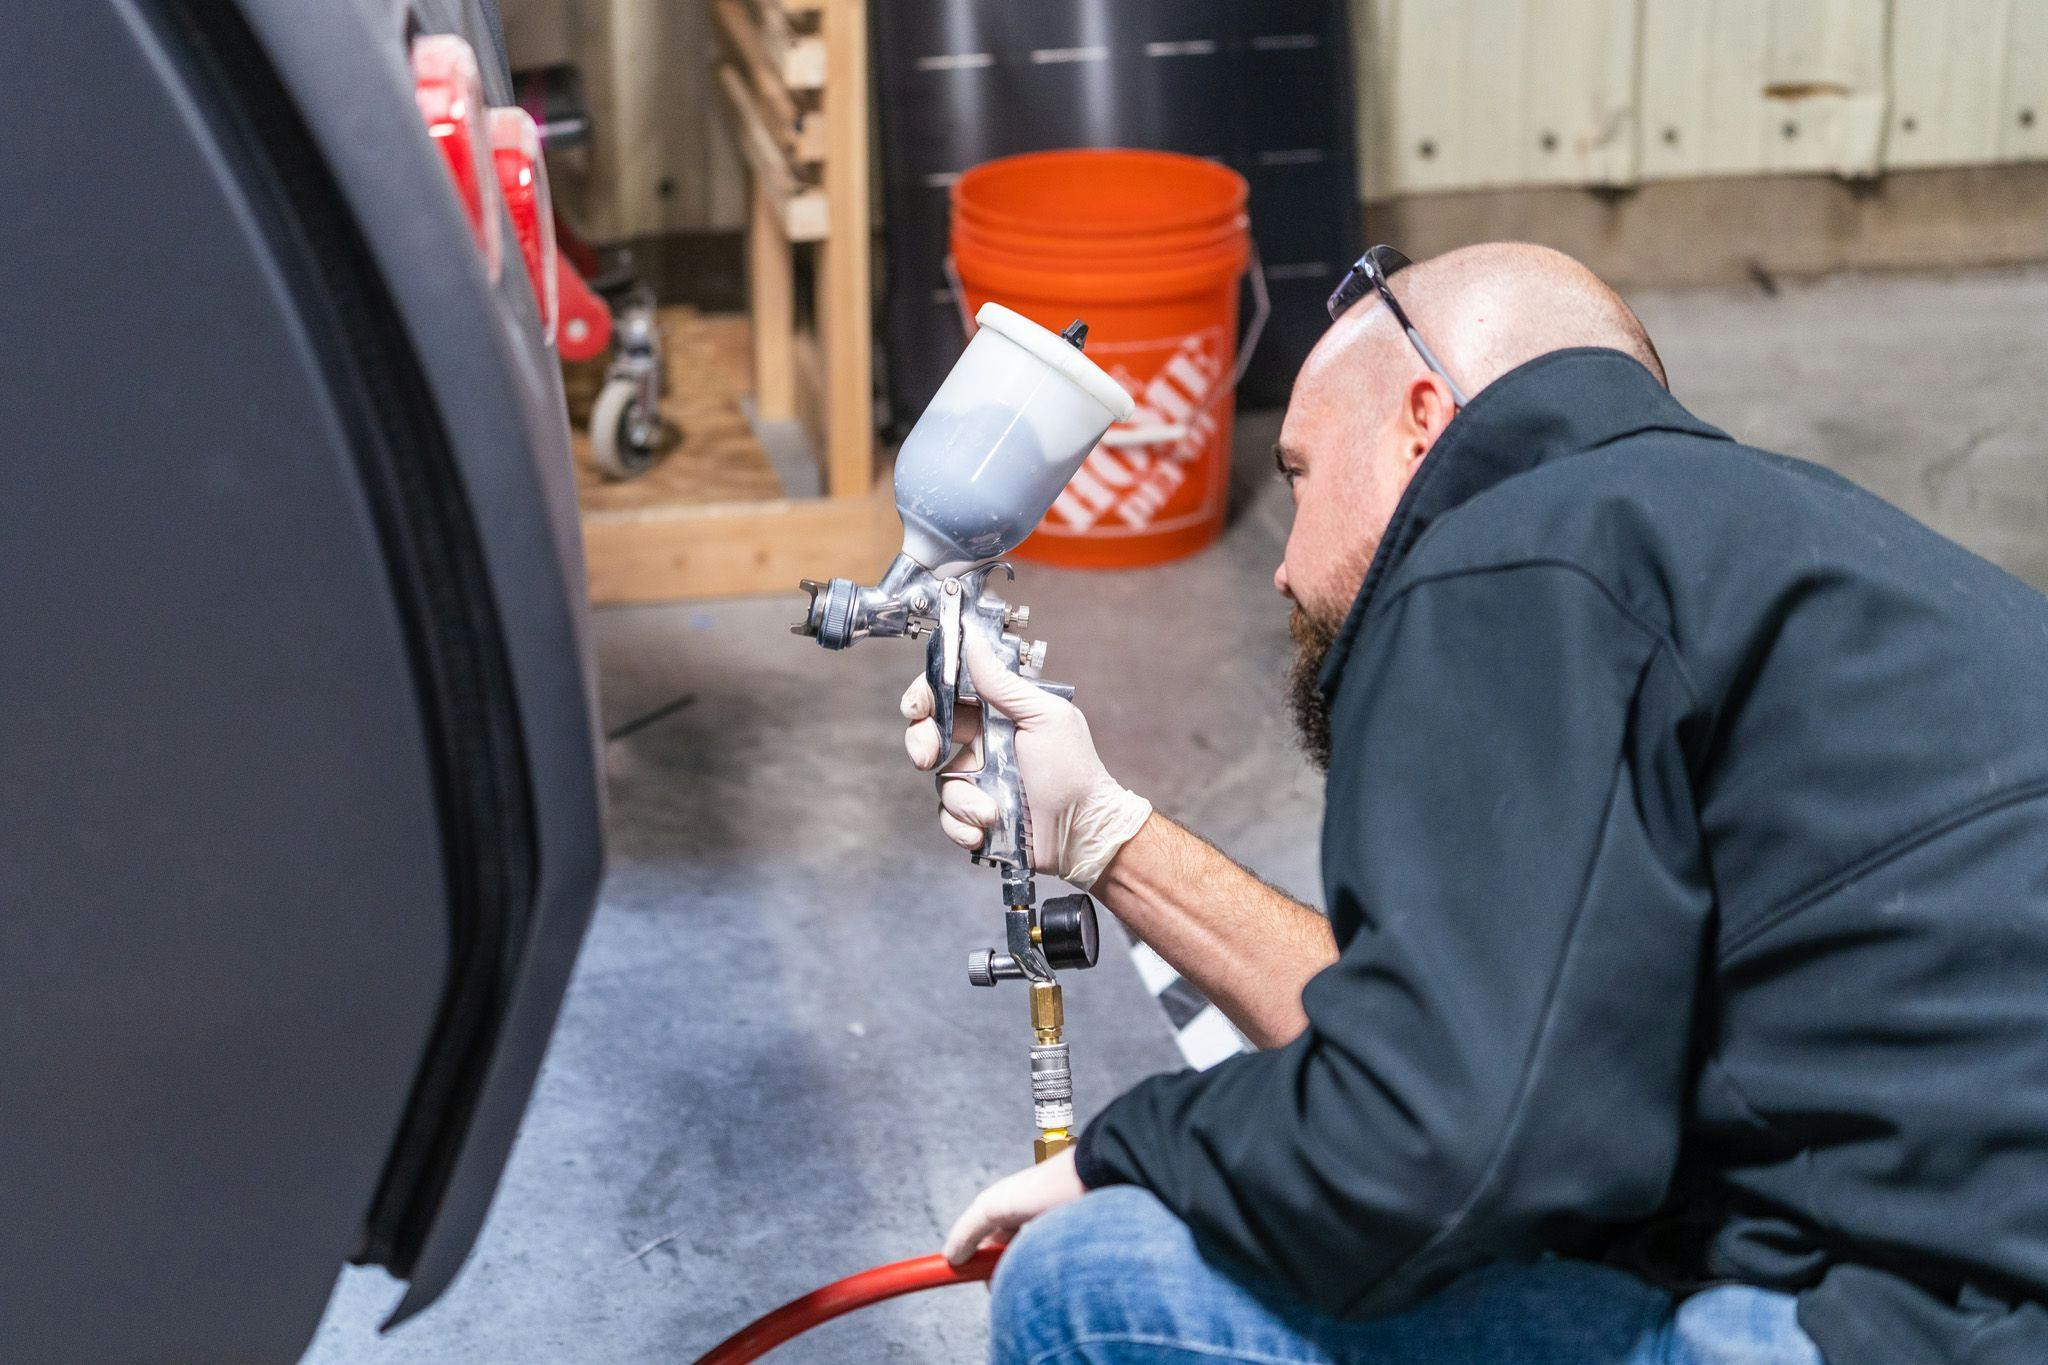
left=903, top=636, right=1151, bottom=890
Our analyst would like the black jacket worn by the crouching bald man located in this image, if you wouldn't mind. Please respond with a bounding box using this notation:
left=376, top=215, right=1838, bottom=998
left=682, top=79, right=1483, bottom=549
left=1079, top=350, right=2048, bottom=1365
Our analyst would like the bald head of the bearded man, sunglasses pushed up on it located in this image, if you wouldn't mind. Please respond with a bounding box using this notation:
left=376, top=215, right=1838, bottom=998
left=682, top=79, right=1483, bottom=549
left=1274, top=241, right=1665, bottom=753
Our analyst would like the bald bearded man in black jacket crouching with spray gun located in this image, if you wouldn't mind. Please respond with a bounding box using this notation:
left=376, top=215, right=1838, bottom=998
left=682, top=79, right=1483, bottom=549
left=905, top=244, right=2048, bottom=1365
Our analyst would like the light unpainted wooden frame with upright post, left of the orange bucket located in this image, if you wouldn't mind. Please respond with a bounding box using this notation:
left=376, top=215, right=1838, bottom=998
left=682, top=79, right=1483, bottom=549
left=584, top=0, right=884, bottom=602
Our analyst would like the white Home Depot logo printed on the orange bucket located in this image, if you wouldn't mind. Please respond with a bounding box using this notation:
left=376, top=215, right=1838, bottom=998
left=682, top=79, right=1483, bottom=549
left=1038, top=327, right=1231, bottom=538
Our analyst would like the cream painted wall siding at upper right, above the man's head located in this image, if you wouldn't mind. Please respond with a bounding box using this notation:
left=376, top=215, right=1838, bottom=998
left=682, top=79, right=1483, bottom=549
left=1354, top=0, right=2048, bottom=199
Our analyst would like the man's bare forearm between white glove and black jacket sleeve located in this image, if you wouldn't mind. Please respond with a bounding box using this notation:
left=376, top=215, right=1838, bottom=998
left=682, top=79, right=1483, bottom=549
left=1094, top=812, right=1337, bottom=1048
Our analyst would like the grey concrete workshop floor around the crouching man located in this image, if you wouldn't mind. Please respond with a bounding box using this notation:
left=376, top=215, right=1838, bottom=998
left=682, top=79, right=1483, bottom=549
left=309, top=263, right=2048, bottom=1365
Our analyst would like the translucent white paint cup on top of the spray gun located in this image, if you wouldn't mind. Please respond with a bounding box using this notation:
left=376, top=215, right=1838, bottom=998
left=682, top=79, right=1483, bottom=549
left=895, top=303, right=1137, bottom=577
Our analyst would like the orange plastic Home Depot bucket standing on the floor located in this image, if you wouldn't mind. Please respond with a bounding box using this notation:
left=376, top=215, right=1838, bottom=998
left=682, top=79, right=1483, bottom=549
left=952, top=151, right=1251, bottom=569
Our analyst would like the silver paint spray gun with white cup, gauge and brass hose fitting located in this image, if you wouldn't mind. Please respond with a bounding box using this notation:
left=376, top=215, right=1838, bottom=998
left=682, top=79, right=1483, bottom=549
left=791, top=303, right=1133, bottom=1160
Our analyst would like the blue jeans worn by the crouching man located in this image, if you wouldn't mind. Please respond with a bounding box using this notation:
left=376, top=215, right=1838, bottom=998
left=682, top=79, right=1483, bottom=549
left=989, top=1187, right=1821, bottom=1365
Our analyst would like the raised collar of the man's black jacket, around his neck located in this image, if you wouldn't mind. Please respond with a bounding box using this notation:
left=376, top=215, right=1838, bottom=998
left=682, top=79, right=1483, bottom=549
left=1321, top=346, right=1729, bottom=696
